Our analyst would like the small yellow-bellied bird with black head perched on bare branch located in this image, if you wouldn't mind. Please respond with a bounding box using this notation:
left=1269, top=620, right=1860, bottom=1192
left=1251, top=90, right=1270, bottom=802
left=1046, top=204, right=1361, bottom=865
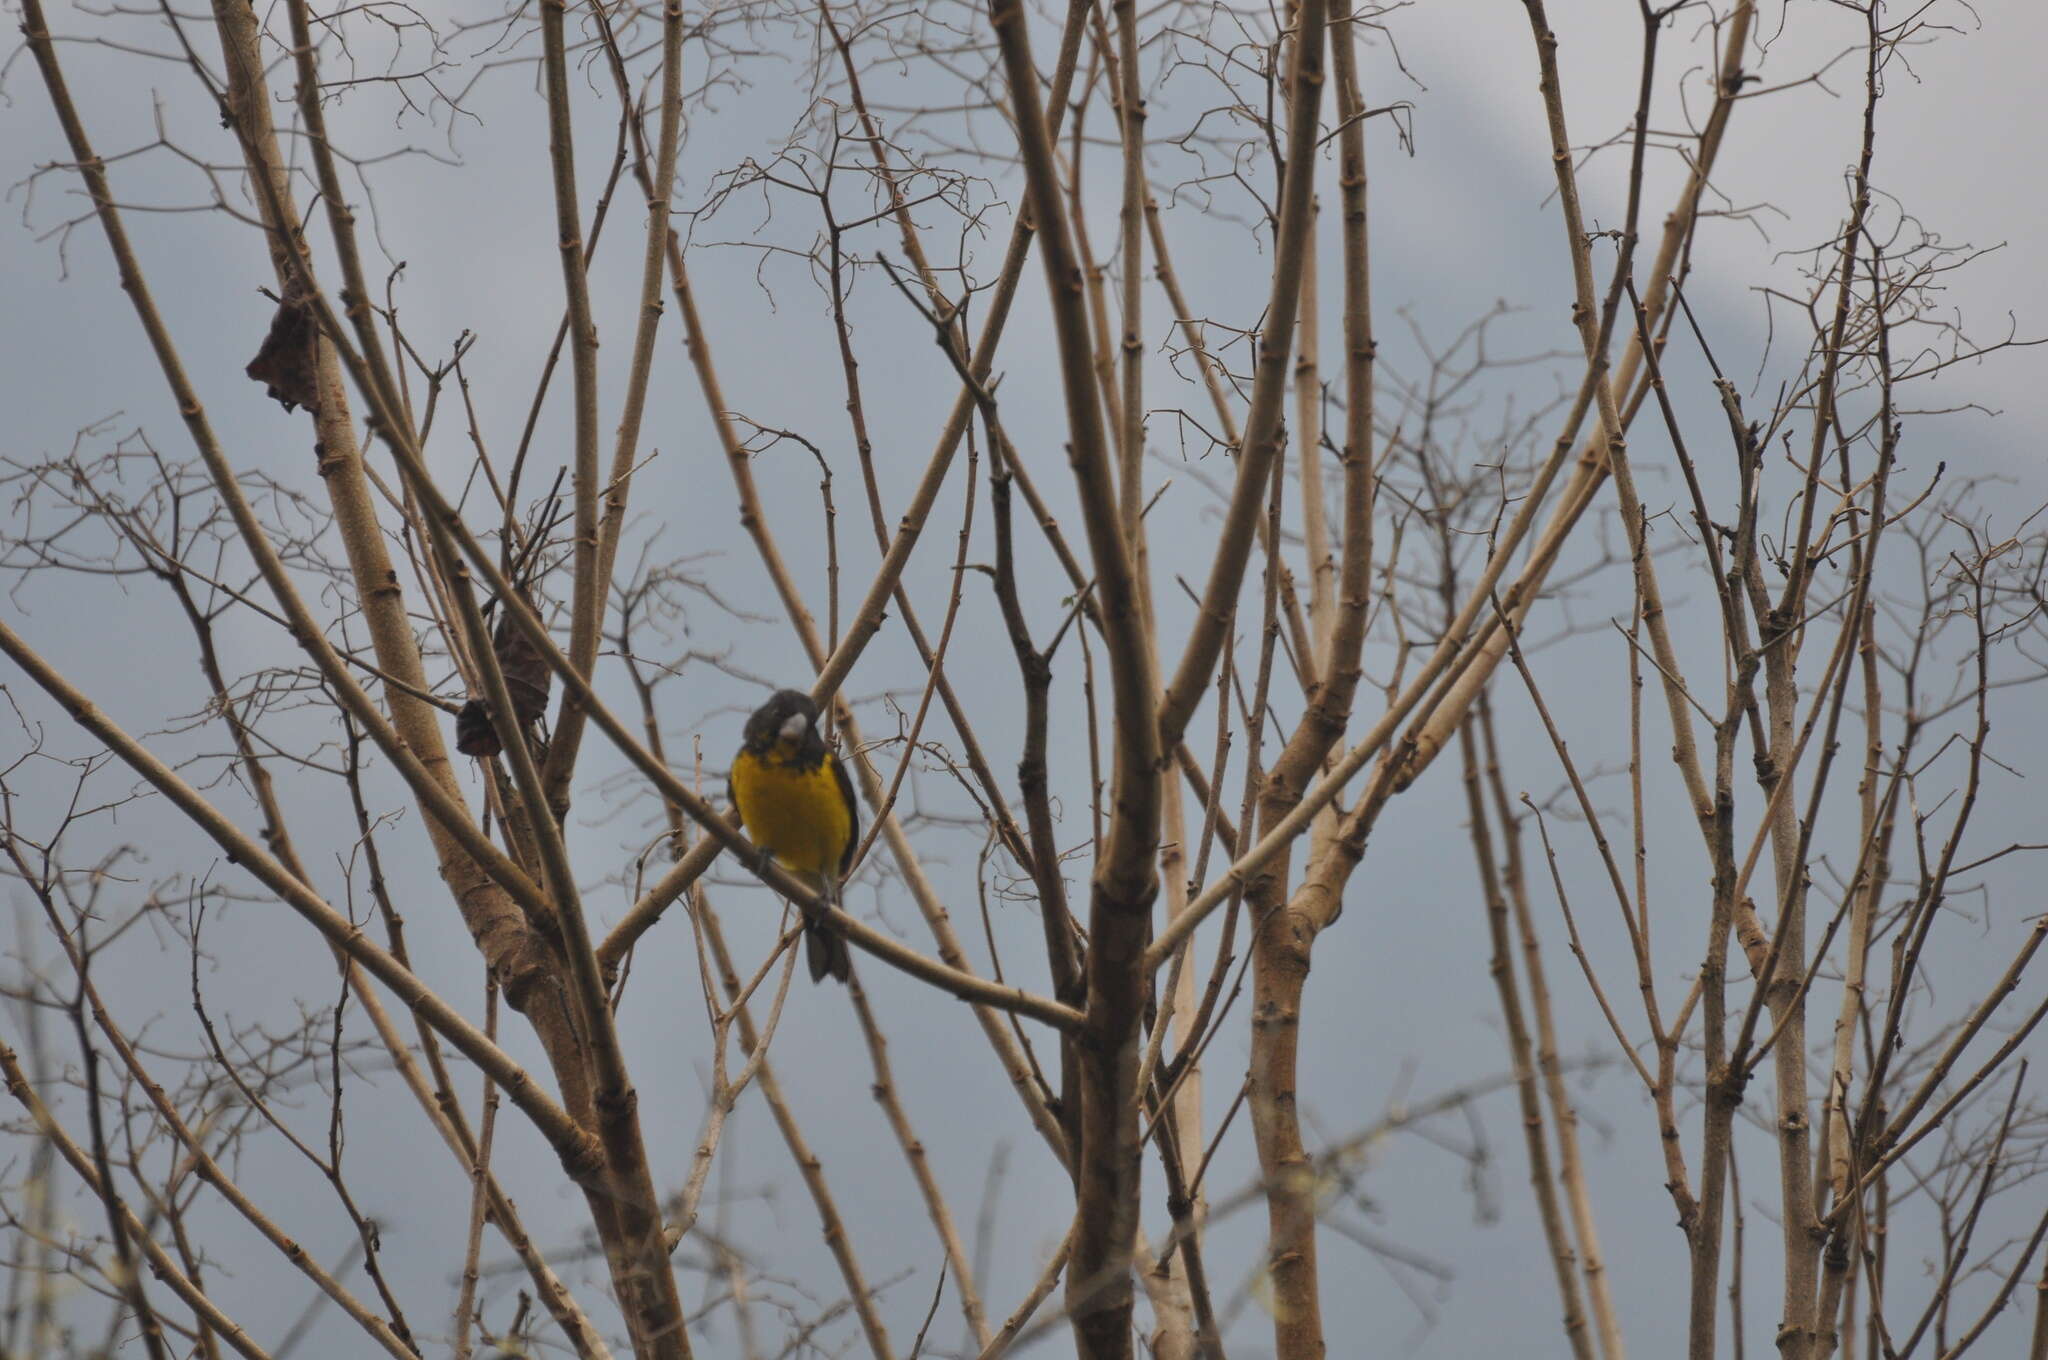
left=727, top=690, right=860, bottom=983
